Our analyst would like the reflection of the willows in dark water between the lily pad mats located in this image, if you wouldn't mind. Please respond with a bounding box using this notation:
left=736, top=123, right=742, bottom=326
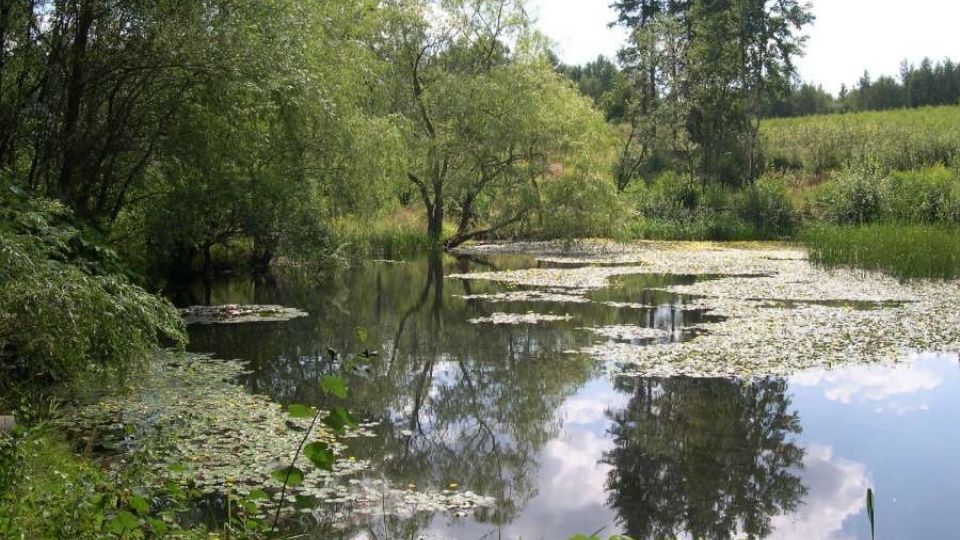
left=181, top=255, right=600, bottom=538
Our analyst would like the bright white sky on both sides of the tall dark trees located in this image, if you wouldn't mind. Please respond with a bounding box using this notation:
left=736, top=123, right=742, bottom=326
left=529, top=0, right=960, bottom=93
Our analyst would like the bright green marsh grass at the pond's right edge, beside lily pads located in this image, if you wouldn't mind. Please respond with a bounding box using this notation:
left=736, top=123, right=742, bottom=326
left=800, top=223, right=960, bottom=281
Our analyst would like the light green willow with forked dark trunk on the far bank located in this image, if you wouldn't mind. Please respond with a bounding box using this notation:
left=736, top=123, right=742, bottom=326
left=382, top=0, right=602, bottom=248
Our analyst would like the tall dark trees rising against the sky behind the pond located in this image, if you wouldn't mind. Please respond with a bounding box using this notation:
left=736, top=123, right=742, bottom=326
left=614, top=0, right=813, bottom=183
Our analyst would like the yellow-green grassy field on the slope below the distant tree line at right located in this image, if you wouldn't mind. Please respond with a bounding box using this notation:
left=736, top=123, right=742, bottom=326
left=761, top=107, right=960, bottom=174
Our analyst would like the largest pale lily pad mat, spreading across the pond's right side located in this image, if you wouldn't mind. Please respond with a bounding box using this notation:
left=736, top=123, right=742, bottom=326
left=451, top=242, right=960, bottom=377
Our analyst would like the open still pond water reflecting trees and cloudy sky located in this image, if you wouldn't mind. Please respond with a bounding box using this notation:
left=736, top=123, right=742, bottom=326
left=175, top=256, right=960, bottom=539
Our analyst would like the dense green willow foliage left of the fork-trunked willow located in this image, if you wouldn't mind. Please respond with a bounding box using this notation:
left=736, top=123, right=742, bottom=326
left=128, top=0, right=400, bottom=270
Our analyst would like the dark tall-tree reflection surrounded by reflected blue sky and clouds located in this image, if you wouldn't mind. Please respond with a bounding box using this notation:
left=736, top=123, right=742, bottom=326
left=604, top=378, right=806, bottom=539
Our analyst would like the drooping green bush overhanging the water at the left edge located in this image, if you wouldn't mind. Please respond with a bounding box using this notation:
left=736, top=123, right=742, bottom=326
left=0, top=186, right=185, bottom=386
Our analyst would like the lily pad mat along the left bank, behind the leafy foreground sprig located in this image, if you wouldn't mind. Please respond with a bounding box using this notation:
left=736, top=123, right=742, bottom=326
left=64, top=354, right=494, bottom=526
